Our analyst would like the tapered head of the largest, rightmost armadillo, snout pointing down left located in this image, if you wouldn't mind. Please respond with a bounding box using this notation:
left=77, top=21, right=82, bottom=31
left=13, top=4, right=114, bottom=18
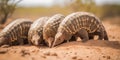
left=51, top=32, right=64, bottom=47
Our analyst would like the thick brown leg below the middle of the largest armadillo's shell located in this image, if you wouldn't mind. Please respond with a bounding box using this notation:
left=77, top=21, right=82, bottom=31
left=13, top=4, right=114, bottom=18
left=76, top=29, right=89, bottom=42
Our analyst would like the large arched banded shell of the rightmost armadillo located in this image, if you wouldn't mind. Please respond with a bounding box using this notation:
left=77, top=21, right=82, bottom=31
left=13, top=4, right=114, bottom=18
left=58, top=12, right=102, bottom=34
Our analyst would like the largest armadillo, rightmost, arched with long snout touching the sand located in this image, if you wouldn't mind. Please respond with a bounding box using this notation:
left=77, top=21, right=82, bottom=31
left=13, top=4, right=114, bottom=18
left=52, top=12, right=108, bottom=47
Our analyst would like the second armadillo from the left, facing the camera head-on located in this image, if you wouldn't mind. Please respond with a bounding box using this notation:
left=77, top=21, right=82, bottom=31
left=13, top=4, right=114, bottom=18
left=28, top=17, right=49, bottom=45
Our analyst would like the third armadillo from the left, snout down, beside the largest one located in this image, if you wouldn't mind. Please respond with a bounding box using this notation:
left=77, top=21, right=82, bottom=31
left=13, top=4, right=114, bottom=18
left=43, top=14, right=64, bottom=47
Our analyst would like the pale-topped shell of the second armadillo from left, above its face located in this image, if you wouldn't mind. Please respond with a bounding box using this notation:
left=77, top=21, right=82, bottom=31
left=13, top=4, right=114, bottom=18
left=28, top=17, right=49, bottom=43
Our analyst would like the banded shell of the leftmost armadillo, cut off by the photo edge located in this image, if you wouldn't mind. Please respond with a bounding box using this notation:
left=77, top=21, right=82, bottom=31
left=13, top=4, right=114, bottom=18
left=0, top=18, right=32, bottom=41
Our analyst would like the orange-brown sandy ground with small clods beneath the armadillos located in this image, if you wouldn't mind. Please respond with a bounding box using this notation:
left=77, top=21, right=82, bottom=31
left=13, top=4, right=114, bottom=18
left=0, top=22, right=120, bottom=60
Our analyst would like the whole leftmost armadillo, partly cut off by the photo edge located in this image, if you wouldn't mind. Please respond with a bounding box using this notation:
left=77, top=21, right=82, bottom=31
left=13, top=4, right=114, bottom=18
left=0, top=19, right=32, bottom=46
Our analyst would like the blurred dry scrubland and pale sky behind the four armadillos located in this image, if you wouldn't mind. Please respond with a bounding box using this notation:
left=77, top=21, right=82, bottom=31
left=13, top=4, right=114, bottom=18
left=0, top=0, right=120, bottom=26
